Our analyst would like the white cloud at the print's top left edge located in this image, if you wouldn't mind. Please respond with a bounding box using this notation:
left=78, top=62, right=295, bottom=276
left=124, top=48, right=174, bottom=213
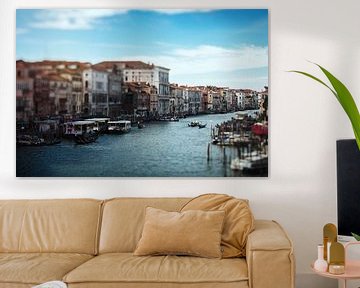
left=31, top=9, right=122, bottom=30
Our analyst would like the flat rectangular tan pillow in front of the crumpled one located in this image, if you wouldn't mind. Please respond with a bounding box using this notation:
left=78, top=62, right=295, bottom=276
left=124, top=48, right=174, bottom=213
left=134, top=207, right=225, bottom=258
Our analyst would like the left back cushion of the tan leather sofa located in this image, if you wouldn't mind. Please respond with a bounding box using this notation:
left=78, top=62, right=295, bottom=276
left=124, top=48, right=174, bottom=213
left=0, top=199, right=103, bottom=254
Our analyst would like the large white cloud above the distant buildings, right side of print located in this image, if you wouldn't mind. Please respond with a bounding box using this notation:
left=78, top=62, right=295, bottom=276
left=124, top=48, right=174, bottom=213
left=104, top=45, right=268, bottom=89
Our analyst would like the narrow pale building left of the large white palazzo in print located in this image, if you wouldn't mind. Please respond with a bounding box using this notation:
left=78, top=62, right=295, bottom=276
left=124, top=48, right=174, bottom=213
left=82, top=67, right=109, bottom=116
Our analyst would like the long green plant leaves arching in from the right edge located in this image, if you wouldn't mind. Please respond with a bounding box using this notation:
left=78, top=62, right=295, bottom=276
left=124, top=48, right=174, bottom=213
left=289, top=63, right=360, bottom=150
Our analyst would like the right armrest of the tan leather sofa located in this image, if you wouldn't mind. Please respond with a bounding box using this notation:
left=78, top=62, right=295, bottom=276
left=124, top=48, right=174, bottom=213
left=246, top=220, right=295, bottom=288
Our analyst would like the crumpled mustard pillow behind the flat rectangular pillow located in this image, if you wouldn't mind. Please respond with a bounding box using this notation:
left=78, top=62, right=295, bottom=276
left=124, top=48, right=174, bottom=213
left=181, top=194, right=254, bottom=258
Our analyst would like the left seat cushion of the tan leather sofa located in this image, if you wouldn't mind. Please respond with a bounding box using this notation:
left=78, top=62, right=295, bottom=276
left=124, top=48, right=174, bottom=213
left=0, top=253, right=93, bottom=286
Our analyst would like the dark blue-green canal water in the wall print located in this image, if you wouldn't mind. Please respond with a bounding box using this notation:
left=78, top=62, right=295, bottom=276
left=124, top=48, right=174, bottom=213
left=16, top=113, right=258, bottom=177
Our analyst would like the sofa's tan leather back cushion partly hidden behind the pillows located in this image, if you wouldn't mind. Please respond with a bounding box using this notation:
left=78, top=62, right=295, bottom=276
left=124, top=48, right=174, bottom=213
left=99, top=198, right=190, bottom=254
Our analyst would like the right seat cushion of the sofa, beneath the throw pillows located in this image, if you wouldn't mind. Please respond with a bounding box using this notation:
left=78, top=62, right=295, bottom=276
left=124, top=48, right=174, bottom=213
left=64, top=253, right=248, bottom=287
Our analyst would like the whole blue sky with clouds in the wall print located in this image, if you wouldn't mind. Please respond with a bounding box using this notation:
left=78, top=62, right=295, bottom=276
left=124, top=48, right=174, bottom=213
left=16, top=9, right=268, bottom=90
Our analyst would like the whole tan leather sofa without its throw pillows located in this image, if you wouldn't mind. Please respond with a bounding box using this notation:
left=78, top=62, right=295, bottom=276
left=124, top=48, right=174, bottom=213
left=0, top=198, right=294, bottom=288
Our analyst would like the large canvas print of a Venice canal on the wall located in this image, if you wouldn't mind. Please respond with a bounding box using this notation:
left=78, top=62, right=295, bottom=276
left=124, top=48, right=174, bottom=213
left=16, top=9, right=269, bottom=177
